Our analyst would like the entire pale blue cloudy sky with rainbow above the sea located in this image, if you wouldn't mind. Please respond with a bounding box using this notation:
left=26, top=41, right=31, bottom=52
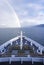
left=0, top=0, right=44, bottom=27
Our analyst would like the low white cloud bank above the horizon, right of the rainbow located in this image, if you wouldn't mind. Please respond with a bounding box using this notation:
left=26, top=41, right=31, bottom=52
left=21, top=11, right=44, bottom=27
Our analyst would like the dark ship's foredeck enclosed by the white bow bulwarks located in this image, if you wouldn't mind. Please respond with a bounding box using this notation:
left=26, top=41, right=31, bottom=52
left=0, top=38, right=44, bottom=57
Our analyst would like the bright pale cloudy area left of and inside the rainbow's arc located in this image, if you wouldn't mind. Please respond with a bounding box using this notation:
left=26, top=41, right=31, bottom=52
left=0, top=0, right=21, bottom=28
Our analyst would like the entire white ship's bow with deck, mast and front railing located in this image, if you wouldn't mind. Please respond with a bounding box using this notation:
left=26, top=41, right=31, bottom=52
left=0, top=31, right=44, bottom=63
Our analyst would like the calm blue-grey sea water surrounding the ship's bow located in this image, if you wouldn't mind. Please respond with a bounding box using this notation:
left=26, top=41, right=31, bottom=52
left=0, top=27, right=44, bottom=46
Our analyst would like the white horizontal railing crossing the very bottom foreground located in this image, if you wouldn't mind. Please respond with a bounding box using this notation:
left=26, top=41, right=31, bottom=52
left=0, top=57, right=44, bottom=64
